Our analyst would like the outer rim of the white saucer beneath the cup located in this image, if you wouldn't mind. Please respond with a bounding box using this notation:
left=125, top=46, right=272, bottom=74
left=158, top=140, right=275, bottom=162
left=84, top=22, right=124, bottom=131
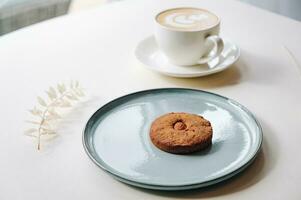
left=134, top=35, right=241, bottom=78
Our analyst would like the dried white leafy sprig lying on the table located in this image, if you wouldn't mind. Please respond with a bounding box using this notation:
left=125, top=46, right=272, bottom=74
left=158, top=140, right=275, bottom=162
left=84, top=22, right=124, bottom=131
left=25, top=81, right=85, bottom=150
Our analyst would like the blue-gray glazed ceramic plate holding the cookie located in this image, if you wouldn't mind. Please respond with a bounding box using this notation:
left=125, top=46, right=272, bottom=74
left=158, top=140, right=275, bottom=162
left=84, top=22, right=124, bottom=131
left=83, top=88, right=262, bottom=190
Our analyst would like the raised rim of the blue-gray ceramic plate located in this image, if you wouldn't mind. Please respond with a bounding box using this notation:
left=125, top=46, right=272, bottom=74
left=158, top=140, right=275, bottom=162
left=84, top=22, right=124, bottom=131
left=82, top=87, right=263, bottom=190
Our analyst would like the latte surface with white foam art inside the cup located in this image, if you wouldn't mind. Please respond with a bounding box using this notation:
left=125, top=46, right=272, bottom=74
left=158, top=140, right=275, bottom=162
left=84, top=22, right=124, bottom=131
left=156, top=8, right=219, bottom=31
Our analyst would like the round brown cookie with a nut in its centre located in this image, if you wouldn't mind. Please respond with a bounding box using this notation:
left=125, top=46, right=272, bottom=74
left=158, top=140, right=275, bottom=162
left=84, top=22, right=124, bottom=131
left=150, top=113, right=213, bottom=154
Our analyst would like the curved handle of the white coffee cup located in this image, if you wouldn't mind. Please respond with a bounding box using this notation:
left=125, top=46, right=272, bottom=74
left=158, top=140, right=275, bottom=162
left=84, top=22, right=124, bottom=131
left=198, top=35, right=224, bottom=64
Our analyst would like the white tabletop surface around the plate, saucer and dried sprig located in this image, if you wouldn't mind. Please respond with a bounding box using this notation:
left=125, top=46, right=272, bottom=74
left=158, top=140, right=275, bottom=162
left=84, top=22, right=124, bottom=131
left=0, top=0, right=301, bottom=200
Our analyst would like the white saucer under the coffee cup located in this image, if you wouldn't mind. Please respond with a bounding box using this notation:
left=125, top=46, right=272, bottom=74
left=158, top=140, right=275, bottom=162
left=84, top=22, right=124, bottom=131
left=135, top=36, right=240, bottom=78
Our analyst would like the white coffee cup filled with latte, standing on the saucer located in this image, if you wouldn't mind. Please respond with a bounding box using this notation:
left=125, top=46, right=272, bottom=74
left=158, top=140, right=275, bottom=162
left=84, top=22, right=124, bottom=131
left=155, top=7, right=224, bottom=66
